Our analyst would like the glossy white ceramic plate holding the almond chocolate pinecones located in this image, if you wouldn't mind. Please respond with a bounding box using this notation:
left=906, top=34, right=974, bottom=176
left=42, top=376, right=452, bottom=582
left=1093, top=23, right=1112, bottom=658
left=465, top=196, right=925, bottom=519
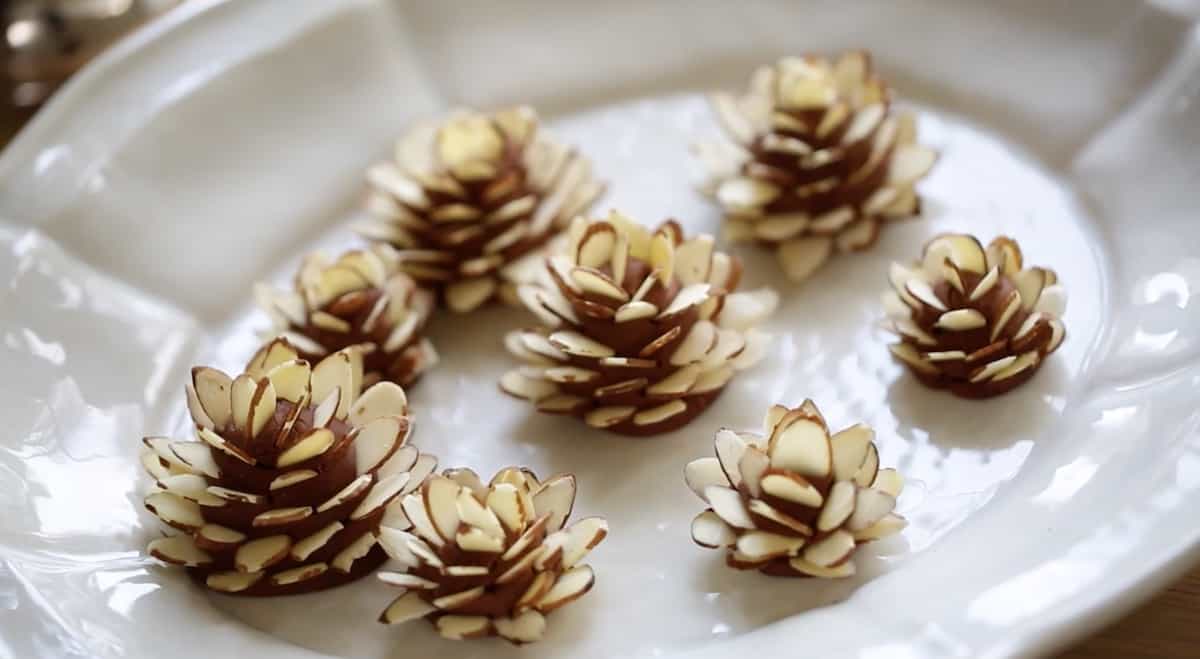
left=0, top=0, right=1200, bottom=659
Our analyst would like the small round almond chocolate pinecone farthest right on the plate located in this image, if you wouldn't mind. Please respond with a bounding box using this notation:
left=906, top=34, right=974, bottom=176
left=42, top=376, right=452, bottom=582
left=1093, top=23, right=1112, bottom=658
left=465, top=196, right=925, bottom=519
left=883, top=234, right=1067, bottom=399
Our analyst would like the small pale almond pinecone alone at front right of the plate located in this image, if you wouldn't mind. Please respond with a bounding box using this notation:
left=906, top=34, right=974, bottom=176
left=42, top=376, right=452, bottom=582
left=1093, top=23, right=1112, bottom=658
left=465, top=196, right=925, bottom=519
left=684, top=401, right=906, bottom=577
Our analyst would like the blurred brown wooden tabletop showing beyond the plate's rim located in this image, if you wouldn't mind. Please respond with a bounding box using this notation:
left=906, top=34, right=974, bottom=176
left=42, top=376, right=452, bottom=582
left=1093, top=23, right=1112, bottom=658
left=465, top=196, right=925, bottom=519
left=0, top=27, right=1200, bottom=659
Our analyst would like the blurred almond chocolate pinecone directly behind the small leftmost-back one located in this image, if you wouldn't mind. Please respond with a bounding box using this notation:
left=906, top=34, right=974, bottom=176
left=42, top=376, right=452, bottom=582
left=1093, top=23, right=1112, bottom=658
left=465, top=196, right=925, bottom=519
left=359, top=107, right=604, bottom=312
